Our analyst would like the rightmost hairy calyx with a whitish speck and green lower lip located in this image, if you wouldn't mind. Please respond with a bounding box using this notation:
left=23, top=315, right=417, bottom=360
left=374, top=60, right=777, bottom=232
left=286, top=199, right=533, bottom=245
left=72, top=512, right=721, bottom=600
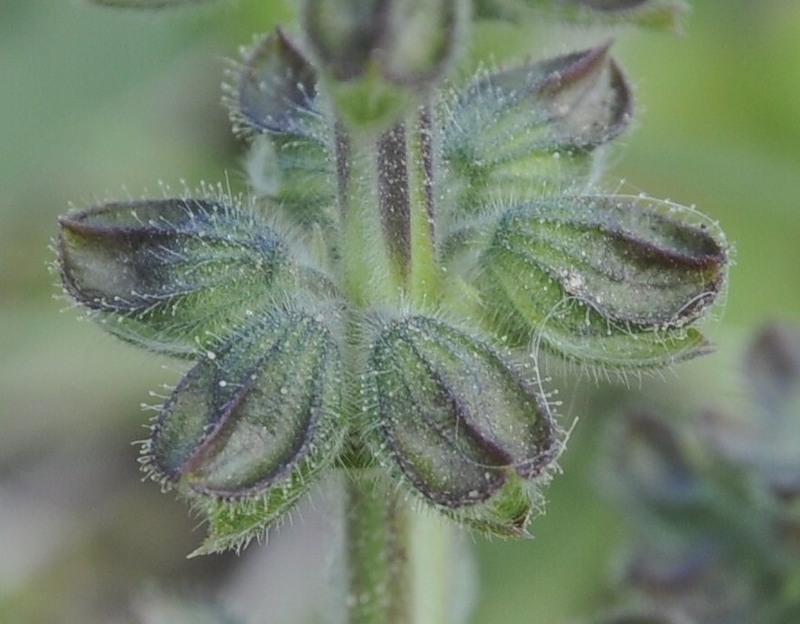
left=466, top=195, right=728, bottom=369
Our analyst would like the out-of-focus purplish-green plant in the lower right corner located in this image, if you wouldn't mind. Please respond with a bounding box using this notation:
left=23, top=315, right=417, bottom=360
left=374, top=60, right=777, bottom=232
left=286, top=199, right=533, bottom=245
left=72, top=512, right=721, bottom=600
left=603, top=324, right=800, bottom=624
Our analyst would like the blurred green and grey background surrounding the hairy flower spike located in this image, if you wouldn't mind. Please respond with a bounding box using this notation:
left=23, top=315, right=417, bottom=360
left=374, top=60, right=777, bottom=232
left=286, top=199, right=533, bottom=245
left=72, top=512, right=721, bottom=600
left=0, top=0, right=800, bottom=624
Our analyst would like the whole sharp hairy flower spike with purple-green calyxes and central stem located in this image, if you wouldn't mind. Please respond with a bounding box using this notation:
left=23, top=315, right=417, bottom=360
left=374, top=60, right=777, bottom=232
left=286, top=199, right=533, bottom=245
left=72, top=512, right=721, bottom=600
left=51, top=0, right=728, bottom=622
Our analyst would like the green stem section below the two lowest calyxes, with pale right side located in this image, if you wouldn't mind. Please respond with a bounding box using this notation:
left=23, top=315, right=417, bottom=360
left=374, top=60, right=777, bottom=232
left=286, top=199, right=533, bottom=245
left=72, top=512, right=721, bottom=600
left=342, top=469, right=468, bottom=624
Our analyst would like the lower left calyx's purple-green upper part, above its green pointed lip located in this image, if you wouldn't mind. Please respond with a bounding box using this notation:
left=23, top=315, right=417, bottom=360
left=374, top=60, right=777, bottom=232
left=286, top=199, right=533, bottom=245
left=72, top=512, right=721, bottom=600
left=143, top=306, right=342, bottom=499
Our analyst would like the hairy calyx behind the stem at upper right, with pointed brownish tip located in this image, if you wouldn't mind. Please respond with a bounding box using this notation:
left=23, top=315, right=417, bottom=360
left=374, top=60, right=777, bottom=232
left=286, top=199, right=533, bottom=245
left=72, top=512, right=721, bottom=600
left=442, top=44, right=633, bottom=220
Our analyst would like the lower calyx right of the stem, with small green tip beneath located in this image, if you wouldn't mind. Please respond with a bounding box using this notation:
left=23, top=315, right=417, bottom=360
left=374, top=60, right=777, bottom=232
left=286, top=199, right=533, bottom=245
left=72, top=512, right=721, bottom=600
left=363, top=316, right=560, bottom=535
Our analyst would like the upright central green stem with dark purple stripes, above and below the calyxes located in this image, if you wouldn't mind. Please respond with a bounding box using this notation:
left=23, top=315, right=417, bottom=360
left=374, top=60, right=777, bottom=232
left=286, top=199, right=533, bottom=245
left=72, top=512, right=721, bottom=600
left=336, top=107, right=462, bottom=624
